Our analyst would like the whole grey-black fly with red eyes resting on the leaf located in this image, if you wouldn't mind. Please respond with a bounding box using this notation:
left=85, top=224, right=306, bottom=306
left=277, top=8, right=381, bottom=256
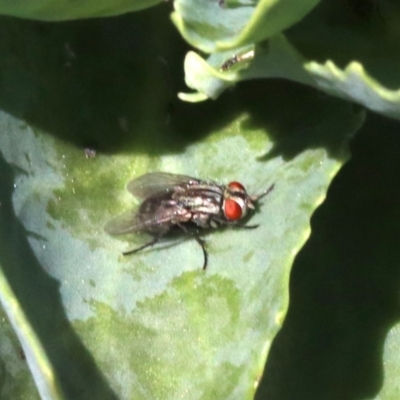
left=105, top=172, right=274, bottom=269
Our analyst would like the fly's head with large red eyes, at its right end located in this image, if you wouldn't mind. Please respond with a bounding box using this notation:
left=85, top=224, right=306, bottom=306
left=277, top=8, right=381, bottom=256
left=222, top=182, right=274, bottom=222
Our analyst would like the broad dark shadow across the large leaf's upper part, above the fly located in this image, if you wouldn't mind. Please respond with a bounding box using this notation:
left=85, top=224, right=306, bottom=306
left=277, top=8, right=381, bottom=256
left=0, top=4, right=360, bottom=160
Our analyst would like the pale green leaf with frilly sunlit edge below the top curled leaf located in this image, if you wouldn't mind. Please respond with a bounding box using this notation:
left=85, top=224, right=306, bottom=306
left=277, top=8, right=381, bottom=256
left=181, top=36, right=400, bottom=119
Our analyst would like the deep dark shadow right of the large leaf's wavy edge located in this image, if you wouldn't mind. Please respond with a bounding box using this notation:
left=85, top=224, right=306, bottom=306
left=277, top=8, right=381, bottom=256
left=256, top=111, right=400, bottom=400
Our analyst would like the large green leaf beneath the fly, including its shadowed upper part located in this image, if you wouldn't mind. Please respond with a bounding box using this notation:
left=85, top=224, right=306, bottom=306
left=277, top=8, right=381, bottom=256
left=0, top=10, right=364, bottom=399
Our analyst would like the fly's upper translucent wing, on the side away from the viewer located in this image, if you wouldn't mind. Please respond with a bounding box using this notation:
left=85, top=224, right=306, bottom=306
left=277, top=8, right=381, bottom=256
left=126, top=172, right=201, bottom=199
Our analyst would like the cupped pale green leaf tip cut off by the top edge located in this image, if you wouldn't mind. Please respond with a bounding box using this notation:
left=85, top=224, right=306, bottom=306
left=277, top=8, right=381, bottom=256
left=171, top=0, right=318, bottom=53
